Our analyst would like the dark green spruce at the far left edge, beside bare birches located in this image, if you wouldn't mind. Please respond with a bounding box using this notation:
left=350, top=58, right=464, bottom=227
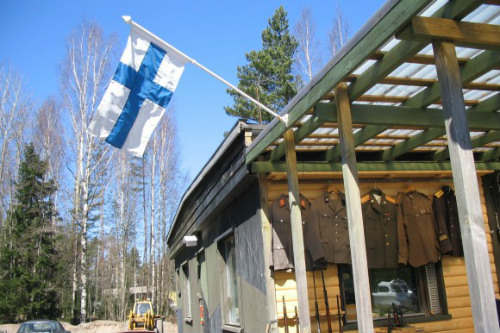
left=0, top=144, right=60, bottom=322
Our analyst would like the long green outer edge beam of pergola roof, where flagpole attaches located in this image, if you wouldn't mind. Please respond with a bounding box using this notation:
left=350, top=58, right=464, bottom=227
left=245, top=0, right=431, bottom=164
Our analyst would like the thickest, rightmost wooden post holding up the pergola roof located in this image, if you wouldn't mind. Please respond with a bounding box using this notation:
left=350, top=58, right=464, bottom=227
left=432, top=41, right=500, bottom=333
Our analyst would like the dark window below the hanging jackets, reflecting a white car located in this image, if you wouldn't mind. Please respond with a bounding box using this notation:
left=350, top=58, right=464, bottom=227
left=338, top=263, right=443, bottom=322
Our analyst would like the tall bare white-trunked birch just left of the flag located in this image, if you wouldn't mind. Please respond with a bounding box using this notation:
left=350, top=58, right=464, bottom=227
left=61, top=22, right=115, bottom=321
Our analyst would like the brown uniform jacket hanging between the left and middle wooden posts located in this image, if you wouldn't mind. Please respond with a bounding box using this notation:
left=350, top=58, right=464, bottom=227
left=306, top=192, right=351, bottom=267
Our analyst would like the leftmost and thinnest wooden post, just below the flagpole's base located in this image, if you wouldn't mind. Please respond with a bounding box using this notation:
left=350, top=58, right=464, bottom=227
left=283, top=129, right=311, bottom=333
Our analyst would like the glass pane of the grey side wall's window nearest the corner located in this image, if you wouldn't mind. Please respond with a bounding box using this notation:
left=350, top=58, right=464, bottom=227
left=224, top=237, right=240, bottom=323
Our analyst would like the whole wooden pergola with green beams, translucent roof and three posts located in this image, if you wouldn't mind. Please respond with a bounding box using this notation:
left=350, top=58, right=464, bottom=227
left=246, top=0, right=500, bottom=333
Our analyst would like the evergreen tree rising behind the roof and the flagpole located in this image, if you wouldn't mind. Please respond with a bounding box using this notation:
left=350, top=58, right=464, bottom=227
left=224, top=6, right=298, bottom=123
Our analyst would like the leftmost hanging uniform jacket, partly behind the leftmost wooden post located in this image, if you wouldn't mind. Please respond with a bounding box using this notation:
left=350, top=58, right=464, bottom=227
left=270, top=194, right=311, bottom=270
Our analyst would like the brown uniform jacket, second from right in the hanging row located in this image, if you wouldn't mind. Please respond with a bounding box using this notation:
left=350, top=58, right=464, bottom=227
left=398, top=191, right=439, bottom=267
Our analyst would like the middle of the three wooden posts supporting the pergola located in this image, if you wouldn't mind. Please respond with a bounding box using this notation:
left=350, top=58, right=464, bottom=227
left=335, top=83, right=373, bottom=333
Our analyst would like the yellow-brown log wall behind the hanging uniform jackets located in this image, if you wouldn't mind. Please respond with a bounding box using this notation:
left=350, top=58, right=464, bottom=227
left=268, top=176, right=500, bottom=333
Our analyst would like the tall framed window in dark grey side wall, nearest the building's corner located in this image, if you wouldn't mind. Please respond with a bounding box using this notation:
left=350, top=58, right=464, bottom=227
left=219, top=235, right=240, bottom=325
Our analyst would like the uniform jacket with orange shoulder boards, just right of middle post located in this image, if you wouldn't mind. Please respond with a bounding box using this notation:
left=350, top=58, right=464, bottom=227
left=361, top=189, right=399, bottom=268
